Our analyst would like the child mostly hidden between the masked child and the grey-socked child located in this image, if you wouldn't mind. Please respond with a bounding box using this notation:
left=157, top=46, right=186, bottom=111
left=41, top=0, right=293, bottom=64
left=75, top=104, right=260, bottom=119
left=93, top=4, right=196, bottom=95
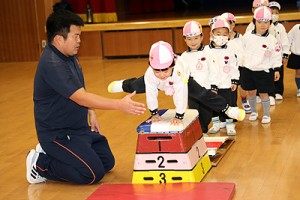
left=221, top=12, right=251, bottom=113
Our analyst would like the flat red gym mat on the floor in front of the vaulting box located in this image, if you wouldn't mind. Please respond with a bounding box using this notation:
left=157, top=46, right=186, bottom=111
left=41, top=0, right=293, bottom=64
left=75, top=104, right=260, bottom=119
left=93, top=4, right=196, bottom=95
left=88, top=182, right=235, bottom=200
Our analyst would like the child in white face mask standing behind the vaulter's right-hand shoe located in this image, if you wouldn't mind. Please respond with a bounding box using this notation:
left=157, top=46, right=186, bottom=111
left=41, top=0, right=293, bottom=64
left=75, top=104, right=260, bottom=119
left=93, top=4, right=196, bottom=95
left=204, top=17, right=240, bottom=135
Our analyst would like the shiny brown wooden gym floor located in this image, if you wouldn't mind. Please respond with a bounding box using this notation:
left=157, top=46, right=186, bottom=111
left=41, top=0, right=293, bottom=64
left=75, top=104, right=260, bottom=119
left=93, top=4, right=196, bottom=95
left=0, top=58, right=300, bottom=200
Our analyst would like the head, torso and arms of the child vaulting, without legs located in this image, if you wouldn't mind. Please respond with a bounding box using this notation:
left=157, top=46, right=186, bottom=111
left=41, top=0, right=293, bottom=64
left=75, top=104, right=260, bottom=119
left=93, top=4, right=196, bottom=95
left=144, top=41, right=190, bottom=125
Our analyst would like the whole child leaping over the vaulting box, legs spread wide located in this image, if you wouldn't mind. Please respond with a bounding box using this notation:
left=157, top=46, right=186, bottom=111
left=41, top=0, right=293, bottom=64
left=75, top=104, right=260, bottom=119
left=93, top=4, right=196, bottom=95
left=108, top=41, right=245, bottom=125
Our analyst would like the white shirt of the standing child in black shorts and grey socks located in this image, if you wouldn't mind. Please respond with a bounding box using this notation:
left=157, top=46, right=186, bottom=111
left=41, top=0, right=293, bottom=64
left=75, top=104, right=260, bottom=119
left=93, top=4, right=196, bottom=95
left=242, top=31, right=282, bottom=72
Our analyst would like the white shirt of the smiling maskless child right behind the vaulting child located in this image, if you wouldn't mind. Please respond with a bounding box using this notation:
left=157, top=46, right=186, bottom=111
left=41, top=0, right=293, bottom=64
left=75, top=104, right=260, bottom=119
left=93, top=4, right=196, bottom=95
left=181, top=46, right=211, bottom=89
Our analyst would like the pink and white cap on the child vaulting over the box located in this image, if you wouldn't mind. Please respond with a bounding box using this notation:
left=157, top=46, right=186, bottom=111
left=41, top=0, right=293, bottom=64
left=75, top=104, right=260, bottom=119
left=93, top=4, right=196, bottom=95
left=149, top=41, right=174, bottom=69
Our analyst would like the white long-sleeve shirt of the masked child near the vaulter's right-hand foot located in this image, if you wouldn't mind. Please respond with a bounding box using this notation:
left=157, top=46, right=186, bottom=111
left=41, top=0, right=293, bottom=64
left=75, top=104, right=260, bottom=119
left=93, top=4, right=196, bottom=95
left=204, top=43, right=240, bottom=89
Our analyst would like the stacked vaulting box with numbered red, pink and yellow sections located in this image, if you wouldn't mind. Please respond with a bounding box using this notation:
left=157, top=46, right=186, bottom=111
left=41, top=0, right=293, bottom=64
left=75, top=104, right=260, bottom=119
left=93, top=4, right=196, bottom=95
left=132, top=109, right=212, bottom=184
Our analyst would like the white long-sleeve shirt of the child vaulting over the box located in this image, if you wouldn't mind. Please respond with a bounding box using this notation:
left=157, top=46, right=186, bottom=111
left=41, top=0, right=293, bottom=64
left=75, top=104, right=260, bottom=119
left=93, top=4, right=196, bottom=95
left=144, top=56, right=190, bottom=114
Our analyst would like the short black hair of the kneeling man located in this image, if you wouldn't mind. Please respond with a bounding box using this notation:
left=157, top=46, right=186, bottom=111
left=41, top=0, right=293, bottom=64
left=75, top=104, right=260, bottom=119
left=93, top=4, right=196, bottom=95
left=46, top=9, right=84, bottom=42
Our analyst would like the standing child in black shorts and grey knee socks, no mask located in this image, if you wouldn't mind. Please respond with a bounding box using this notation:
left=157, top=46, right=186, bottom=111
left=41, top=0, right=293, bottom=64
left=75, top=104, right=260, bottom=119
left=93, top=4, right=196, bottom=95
left=241, top=6, right=282, bottom=124
